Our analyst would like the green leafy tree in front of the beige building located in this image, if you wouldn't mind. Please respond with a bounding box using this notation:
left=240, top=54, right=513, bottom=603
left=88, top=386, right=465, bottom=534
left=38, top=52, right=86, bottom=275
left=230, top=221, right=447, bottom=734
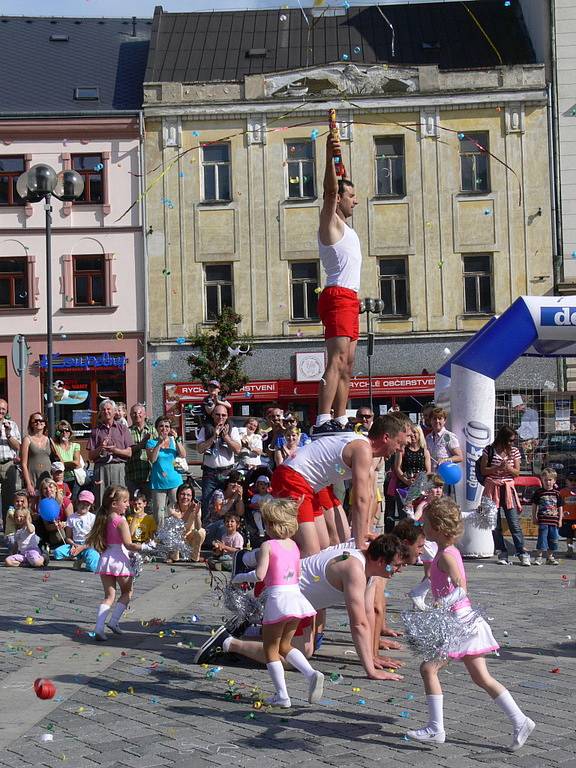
left=188, top=307, right=252, bottom=394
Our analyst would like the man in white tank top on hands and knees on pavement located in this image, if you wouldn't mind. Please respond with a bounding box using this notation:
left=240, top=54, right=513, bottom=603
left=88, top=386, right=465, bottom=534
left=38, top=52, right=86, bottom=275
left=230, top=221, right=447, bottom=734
left=194, top=534, right=409, bottom=680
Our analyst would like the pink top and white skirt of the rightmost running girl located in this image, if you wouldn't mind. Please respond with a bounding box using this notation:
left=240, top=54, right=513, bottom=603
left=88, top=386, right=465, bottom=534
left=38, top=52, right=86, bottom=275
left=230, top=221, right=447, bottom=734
left=430, top=545, right=500, bottom=659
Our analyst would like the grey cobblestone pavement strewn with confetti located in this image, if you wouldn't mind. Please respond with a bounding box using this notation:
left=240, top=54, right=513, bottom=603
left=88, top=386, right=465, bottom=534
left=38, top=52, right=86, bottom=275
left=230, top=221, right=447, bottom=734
left=0, top=544, right=576, bottom=768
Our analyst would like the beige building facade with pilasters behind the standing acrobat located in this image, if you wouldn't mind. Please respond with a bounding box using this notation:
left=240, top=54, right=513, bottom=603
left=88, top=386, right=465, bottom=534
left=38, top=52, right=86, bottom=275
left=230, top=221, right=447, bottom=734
left=144, top=58, right=554, bottom=420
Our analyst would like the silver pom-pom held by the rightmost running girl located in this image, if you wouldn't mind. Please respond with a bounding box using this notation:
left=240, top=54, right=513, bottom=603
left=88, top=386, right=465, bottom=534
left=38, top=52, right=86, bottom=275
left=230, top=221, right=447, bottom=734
left=400, top=607, right=480, bottom=661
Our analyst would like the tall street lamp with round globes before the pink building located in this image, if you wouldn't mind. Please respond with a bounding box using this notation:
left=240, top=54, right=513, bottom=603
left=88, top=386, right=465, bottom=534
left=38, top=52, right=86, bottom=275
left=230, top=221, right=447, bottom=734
left=16, top=163, right=84, bottom=437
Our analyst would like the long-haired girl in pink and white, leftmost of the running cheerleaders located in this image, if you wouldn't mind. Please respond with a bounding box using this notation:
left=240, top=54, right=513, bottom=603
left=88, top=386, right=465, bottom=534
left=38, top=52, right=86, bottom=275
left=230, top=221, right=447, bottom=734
left=86, top=485, right=154, bottom=640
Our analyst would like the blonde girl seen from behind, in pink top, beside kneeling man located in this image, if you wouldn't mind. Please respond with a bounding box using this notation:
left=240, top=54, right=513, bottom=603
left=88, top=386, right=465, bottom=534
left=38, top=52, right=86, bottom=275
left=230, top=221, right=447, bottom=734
left=242, top=499, right=324, bottom=709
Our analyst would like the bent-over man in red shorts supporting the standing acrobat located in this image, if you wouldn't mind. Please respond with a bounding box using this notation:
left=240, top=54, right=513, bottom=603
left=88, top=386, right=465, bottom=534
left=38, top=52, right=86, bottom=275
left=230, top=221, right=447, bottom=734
left=271, top=414, right=409, bottom=557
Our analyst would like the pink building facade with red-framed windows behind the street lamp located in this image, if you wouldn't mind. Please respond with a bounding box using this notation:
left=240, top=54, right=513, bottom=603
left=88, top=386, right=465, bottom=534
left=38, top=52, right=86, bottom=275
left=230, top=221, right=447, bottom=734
left=0, top=113, right=146, bottom=437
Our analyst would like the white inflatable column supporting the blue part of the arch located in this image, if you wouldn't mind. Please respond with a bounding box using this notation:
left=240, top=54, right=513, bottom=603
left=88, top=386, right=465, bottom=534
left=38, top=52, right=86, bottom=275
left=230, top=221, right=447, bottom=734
left=450, top=364, right=496, bottom=557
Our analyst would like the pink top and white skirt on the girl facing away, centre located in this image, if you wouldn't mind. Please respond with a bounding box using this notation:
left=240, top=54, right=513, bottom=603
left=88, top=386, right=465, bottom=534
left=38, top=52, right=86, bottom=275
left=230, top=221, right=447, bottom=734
left=262, top=539, right=316, bottom=624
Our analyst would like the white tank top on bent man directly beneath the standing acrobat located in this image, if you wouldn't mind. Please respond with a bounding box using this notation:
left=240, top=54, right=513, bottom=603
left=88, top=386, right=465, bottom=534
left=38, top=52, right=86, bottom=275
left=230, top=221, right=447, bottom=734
left=284, top=432, right=369, bottom=491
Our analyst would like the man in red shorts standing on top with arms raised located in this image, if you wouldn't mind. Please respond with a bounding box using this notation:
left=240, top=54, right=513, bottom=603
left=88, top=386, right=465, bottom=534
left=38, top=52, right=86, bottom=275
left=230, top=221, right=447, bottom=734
left=314, top=134, right=362, bottom=436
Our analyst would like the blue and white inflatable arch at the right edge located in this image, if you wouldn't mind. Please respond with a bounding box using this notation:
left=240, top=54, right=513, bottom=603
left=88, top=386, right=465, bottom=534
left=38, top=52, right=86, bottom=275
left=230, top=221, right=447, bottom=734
left=435, top=296, right=576, bottom=557
